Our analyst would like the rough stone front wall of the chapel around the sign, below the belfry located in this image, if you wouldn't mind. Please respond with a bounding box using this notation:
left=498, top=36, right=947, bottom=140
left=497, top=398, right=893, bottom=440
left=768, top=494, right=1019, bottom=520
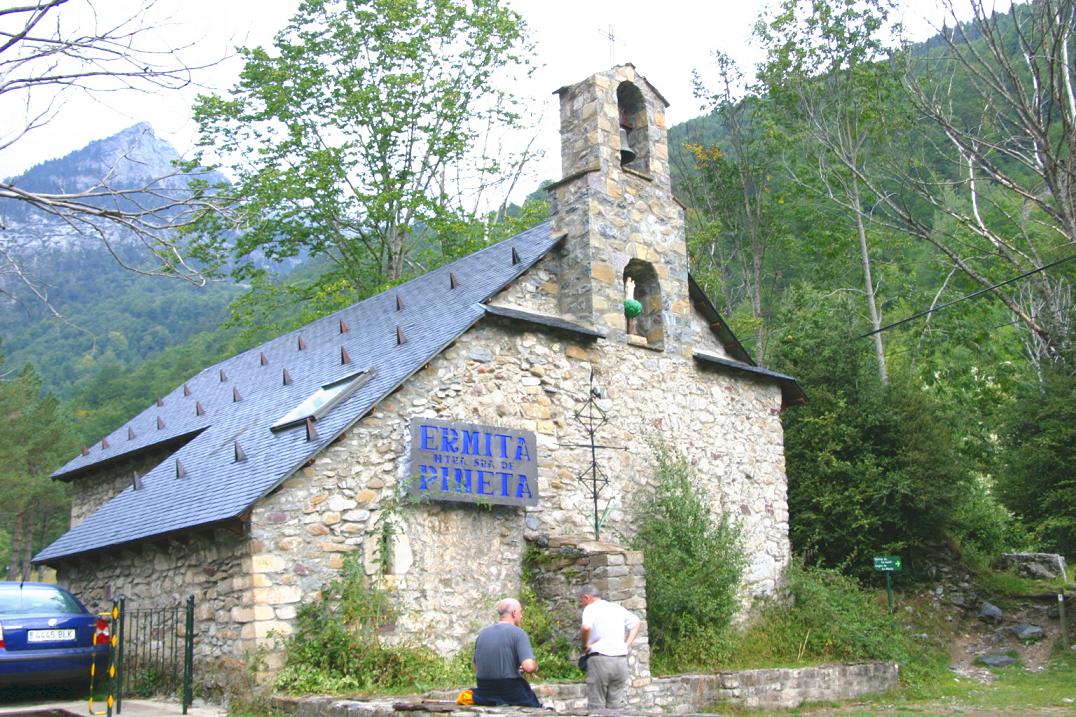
left=237, top=310, right=789, bottom=669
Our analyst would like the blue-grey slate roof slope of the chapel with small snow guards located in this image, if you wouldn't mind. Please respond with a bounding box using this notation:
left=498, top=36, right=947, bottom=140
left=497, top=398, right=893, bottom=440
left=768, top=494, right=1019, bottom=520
left=33, top=222, right=561, bottom=563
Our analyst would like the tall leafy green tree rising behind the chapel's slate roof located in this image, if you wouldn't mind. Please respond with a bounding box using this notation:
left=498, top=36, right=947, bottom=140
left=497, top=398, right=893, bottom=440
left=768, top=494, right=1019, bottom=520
left=195, top=0, right=538, bottom=300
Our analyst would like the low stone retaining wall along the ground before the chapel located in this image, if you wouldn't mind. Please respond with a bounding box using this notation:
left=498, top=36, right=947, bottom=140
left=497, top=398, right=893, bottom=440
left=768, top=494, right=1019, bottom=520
left=273, top=662, right=900, bottom=717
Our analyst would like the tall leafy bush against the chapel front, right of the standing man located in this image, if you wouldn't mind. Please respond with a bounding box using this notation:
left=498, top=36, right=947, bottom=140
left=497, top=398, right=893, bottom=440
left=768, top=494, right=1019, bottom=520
left=634, top=440, right=747, bottom=672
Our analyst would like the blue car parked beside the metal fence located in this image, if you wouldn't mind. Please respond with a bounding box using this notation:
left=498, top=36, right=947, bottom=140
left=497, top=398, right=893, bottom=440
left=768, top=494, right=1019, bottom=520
left=0, top=582, right=109, bottom=685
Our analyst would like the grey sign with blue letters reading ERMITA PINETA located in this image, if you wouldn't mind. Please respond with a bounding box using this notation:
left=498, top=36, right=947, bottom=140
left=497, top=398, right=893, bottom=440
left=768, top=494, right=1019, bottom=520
left=410, top=418, right=538, bottom=506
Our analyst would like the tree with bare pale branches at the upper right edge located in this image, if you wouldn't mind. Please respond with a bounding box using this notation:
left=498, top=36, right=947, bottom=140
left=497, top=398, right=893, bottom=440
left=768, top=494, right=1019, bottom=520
left=850, top=0, right=1076, bottom=365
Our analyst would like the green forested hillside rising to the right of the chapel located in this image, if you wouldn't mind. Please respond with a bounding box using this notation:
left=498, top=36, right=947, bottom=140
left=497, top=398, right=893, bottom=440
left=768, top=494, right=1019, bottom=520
left=670, top=0, right=1076, bottom=574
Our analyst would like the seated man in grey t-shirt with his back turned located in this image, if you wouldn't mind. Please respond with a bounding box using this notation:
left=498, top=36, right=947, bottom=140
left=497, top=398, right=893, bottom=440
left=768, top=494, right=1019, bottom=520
left=475, top=598, right=541, bottom=707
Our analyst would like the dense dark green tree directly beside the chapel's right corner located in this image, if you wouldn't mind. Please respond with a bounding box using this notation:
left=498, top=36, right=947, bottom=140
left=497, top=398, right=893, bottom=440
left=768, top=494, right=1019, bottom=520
left=774, top=289, right=973, bottom=575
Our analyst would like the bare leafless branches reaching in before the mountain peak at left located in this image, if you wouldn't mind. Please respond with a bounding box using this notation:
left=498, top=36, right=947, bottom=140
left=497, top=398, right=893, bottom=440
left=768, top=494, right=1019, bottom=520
left=0, top=0, right=231, bottom=303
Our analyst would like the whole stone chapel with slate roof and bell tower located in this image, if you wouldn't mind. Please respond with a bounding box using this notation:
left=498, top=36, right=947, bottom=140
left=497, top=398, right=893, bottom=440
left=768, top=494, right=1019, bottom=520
left=34, top=65, right=804, bottom=670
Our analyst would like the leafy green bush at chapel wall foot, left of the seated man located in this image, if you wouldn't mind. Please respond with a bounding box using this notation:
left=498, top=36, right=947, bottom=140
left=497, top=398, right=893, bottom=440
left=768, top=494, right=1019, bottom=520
left=277, top=558, right=471, bottom=693
